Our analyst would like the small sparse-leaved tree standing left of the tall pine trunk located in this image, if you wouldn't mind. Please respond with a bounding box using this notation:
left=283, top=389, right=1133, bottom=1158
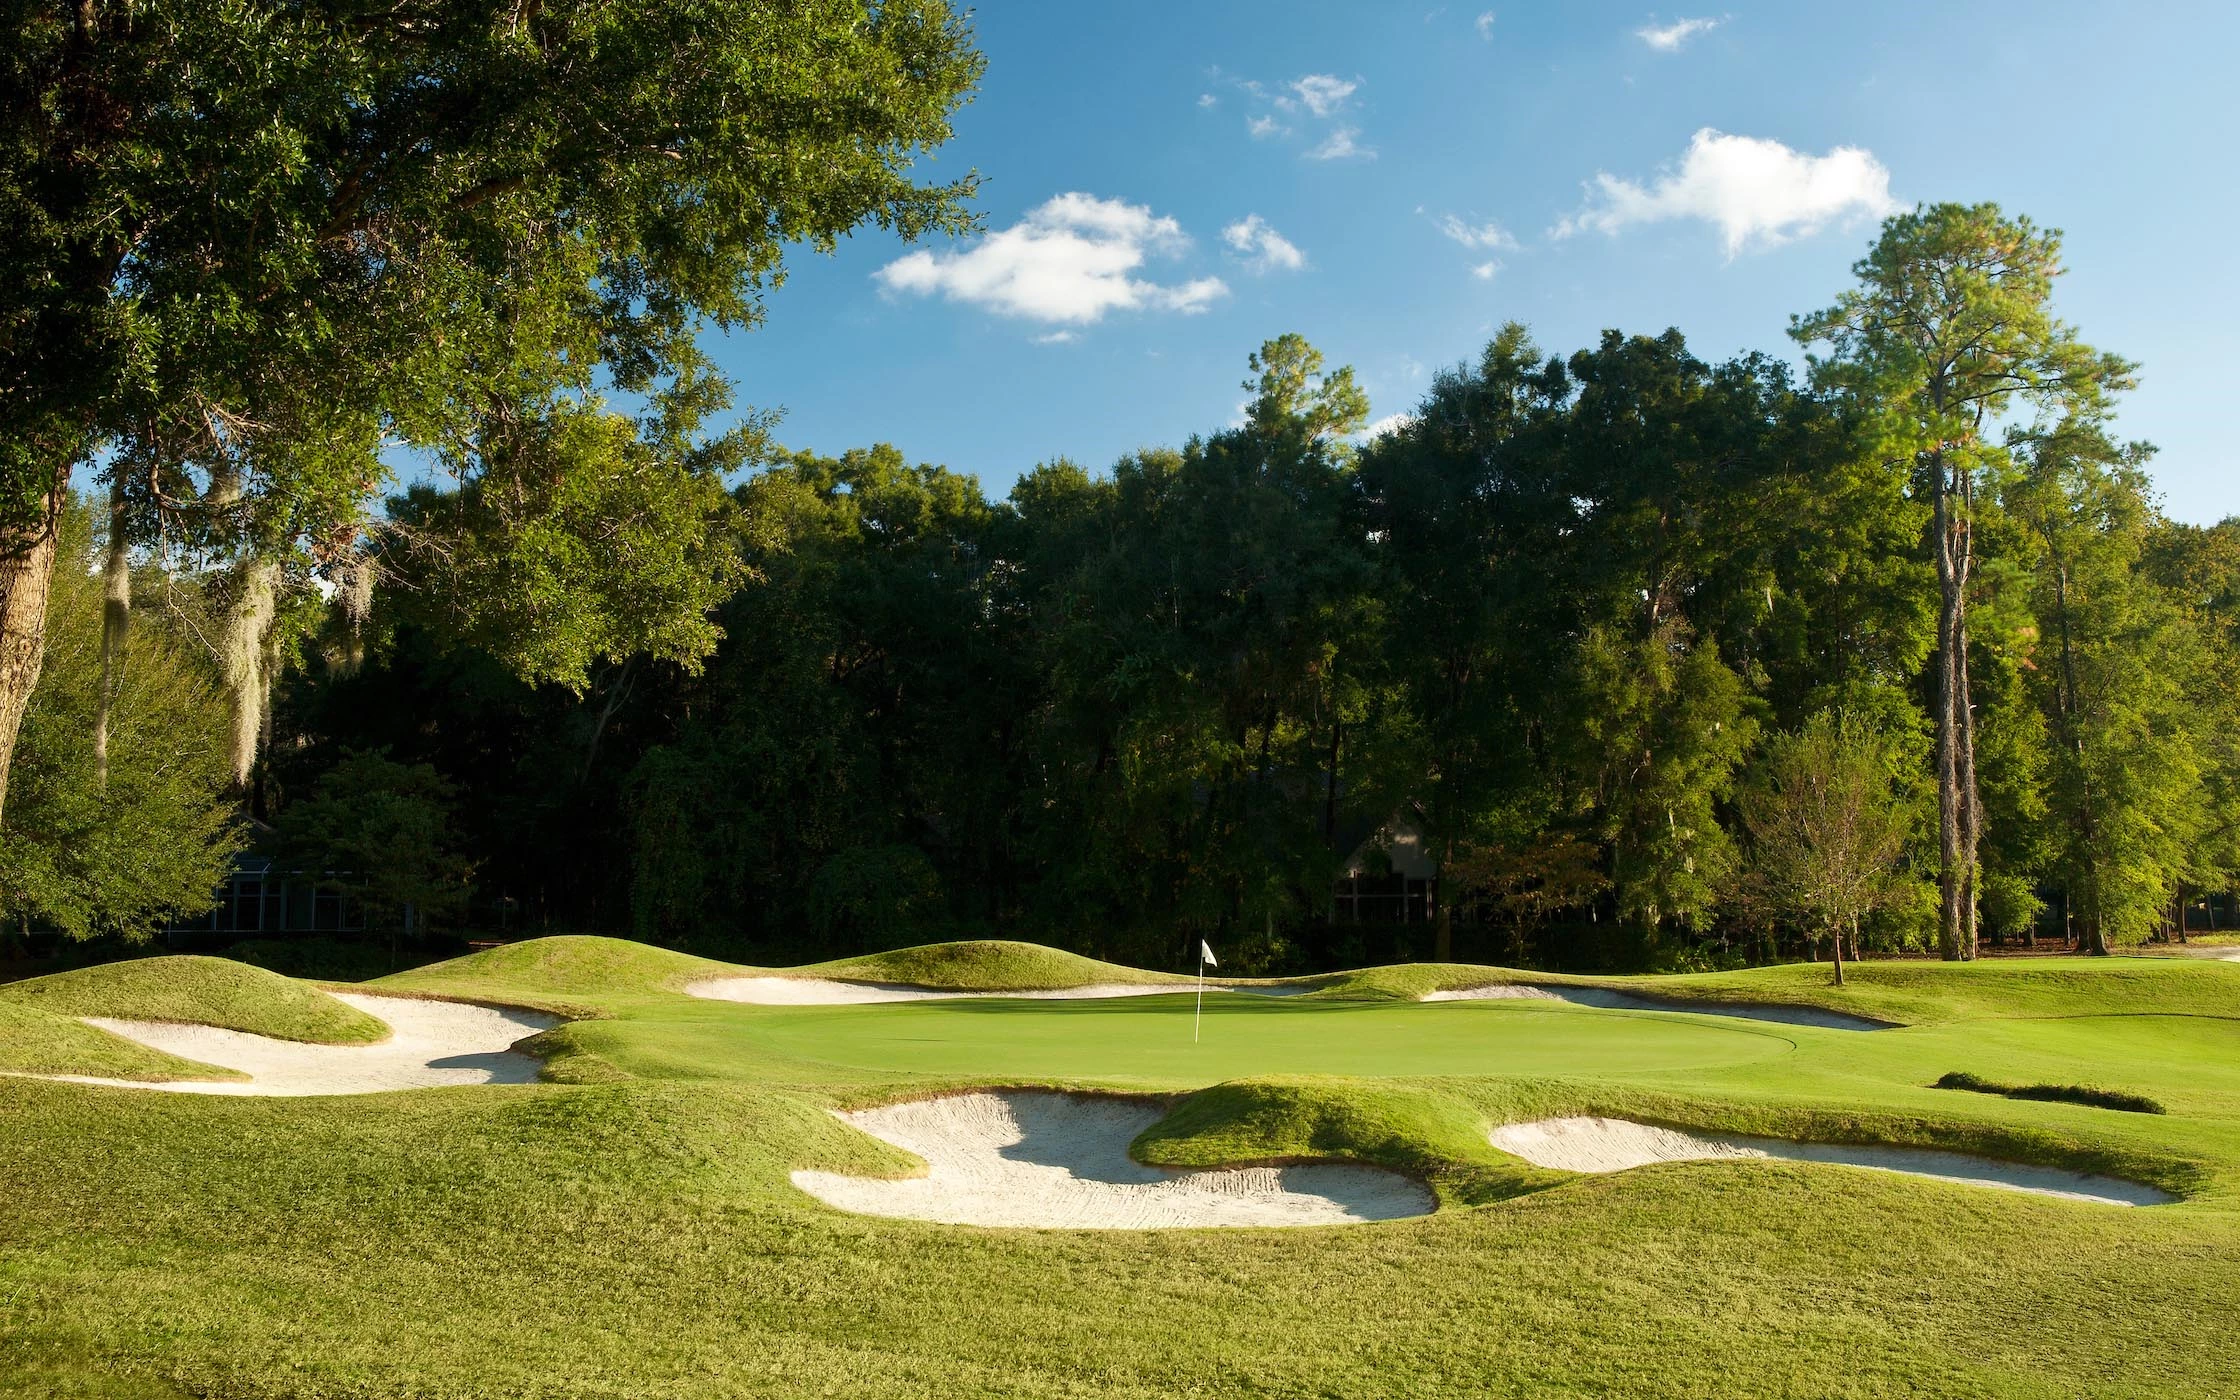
left=1740, top=710, right=1915, bottom=986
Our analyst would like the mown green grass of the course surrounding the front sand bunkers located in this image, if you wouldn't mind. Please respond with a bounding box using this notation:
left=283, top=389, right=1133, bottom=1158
left=0, top=939, right=2240, bottom=1400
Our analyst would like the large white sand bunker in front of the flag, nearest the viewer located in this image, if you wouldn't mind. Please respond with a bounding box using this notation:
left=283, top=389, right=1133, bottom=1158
left=793, top=1091, right=1436, bottom=1230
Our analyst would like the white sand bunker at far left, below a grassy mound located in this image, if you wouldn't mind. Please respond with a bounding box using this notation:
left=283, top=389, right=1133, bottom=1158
left=59, top=992, right=560, bottom=1098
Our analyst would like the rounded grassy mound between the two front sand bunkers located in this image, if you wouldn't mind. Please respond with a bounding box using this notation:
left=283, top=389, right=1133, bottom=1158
left=1129, top=1077, right=1568, bottom=1205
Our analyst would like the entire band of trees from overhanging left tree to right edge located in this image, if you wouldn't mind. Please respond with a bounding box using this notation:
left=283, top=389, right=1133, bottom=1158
left=0, top=0, right=2240, bottom=968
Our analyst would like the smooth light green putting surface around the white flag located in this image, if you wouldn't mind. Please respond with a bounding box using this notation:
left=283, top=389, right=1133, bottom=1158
left=680, top=997, right=1800, bottom=1086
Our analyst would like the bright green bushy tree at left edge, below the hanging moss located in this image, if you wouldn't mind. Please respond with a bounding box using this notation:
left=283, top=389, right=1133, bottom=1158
left=0, top=506, right=242, bottom=939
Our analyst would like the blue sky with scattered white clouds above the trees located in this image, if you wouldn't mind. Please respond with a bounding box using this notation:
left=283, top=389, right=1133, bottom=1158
left=717, top=0, right=2240, bottom=522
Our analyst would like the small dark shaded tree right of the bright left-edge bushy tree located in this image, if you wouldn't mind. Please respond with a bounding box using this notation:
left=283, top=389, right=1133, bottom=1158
left=271, top=753, right=473, bottom=932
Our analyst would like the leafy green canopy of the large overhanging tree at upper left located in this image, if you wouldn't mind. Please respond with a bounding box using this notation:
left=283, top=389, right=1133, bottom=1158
left=0, top=0, right=981, bottom=824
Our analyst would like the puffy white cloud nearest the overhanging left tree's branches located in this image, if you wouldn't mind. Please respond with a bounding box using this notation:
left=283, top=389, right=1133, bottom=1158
left=874, top=193, right=1230, bottom=325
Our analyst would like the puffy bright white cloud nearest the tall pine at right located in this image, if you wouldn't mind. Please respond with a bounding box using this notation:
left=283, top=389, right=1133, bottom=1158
left=1552, top=128, right=1900, bottom=258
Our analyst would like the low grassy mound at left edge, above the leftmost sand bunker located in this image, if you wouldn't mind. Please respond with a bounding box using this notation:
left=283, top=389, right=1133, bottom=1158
left=0, top=956, right=390, bottom=1046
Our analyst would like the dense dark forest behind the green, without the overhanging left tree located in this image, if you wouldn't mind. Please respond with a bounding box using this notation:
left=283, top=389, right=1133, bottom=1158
left=35, top=206, right=2195, bottom=968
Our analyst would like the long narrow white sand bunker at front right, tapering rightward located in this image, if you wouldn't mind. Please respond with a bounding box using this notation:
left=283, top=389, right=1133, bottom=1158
left=1490, top=1118, right=2177, bottom=1205
